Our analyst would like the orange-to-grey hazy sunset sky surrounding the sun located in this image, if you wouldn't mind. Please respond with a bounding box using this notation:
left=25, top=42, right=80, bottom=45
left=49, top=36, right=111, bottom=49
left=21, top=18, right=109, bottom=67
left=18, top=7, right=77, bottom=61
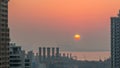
left=9, top=0, right=120, bottom=51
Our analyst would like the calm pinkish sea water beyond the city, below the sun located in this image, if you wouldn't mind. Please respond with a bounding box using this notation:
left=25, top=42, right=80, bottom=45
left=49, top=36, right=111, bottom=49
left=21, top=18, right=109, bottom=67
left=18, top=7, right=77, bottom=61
left=62, top=52, right=110, bottom=61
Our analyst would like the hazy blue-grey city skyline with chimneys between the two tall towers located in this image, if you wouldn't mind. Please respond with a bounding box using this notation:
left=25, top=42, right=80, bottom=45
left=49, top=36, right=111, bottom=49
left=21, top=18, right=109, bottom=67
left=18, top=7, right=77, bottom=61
left=10, top=43, right=110, bottom=68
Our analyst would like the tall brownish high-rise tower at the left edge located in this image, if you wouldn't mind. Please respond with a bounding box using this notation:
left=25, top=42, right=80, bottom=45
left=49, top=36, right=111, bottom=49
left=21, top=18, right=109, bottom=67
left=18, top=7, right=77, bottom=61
left=0, top=0, right=10, bottom=68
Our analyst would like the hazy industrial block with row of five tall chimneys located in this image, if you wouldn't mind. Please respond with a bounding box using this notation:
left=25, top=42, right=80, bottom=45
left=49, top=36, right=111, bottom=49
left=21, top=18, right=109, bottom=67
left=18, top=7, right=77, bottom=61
left=38, top=47, right=60, bottom=62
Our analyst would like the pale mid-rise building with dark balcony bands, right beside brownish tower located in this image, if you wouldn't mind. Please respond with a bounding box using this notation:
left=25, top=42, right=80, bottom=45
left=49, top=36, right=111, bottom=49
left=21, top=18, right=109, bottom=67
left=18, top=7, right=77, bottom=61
left=10, top=44, right=25, bottom=68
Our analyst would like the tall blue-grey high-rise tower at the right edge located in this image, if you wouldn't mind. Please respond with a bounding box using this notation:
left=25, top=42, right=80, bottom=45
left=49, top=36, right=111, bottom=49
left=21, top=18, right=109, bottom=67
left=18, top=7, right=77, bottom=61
left=111, top=10, right=120, bottom=68
